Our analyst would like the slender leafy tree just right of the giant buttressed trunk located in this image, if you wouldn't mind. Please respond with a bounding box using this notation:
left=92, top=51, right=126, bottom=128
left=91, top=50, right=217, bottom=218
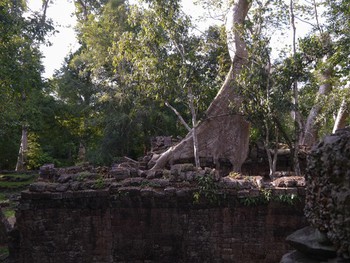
left=237, top=1, right=288, bottom=178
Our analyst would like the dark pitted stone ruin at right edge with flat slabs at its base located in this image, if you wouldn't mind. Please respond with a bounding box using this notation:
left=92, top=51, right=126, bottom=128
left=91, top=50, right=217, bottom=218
left=281, top=128, right=350, bottom=263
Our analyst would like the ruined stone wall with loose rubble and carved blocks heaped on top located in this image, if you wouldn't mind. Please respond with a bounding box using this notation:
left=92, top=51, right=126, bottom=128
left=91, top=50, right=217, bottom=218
left=0, top=137, right=312, bottom=263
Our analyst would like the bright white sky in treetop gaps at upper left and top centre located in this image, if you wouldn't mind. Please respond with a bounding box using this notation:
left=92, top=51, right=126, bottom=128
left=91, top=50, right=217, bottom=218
left=28, top=0, right=213, bottom=78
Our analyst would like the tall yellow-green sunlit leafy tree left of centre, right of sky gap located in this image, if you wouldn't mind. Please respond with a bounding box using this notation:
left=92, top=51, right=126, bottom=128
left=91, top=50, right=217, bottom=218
left=67, top=1, right=189, bottom=162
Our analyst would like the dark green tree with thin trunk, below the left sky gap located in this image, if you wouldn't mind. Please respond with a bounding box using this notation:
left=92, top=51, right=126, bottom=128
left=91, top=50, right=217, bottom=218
left=52, top=49, right=99, bottom=162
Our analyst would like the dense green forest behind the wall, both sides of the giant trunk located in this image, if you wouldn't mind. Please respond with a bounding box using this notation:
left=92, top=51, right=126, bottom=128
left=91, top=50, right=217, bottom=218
left=0, top=0, right=350, bottom=170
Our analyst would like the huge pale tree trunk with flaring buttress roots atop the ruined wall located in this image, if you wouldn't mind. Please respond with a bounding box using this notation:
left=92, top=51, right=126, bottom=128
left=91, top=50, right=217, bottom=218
left=152, top=0, right=250, bottom=171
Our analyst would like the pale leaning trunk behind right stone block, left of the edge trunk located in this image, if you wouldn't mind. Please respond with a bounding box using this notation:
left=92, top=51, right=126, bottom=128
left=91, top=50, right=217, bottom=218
left=301, top=69, right=332, bottom=147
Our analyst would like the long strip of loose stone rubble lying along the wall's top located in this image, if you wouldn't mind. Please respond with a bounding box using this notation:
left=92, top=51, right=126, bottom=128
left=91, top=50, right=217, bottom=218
left=28, top=161, right=305, bottom=204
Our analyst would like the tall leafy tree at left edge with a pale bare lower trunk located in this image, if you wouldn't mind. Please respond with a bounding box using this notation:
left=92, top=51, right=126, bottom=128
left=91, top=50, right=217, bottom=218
left=0, top=0, right=53, bottom=170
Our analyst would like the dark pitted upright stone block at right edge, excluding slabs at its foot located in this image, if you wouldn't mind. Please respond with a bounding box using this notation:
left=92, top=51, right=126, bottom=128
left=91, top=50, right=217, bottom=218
left=305, top=128, right=350, bottom=260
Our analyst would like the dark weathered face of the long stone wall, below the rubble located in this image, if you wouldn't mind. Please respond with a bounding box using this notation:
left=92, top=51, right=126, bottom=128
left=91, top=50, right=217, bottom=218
left=10, top=178, right=306, bottom=263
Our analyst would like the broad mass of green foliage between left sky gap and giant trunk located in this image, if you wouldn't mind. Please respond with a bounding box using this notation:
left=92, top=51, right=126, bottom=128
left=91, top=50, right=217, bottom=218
left=42, top=1, right=230, bottom=167
